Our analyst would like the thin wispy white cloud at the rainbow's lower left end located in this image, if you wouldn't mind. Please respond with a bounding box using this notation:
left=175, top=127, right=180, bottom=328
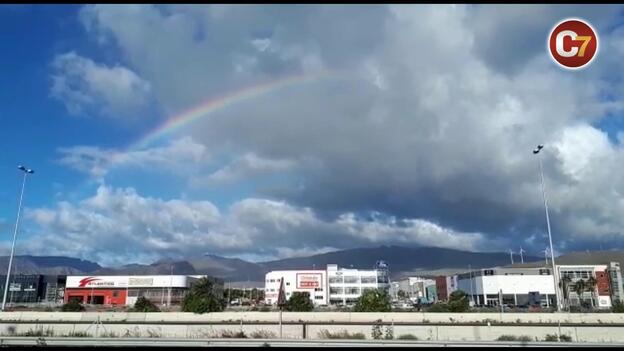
left=58, top=137, right=210, bottom=181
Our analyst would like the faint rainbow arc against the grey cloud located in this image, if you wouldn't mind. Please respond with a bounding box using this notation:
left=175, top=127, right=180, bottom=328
left=128, top=71, right=343, bottom=150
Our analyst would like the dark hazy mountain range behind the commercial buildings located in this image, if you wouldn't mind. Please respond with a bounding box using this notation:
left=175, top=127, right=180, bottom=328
left=0, top=246, right=624, bottom=286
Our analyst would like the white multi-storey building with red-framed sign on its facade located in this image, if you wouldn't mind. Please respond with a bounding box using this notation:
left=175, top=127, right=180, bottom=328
left=265, top=262, right=390, bottom=305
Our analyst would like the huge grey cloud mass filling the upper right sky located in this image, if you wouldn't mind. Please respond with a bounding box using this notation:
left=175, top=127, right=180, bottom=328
left=58, top=5, right=624, bottom=258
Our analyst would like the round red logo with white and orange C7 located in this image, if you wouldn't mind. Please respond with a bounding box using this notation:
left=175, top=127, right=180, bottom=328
left=548, top=18, right=598, bottom=69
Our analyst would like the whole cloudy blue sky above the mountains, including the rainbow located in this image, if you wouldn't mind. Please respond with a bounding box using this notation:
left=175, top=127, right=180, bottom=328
left=0, top=4, right=624, bottom=265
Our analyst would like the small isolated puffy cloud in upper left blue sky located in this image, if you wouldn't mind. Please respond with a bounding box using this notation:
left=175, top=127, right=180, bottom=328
left=50, top=51, right=151, bottom=118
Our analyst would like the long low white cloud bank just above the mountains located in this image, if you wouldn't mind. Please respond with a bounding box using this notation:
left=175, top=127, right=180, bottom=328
left=20, top=185, right=484, bottom=265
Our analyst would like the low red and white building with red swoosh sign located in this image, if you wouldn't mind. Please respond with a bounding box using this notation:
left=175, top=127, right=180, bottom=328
left=65, top=275, right=223, bottom=306
